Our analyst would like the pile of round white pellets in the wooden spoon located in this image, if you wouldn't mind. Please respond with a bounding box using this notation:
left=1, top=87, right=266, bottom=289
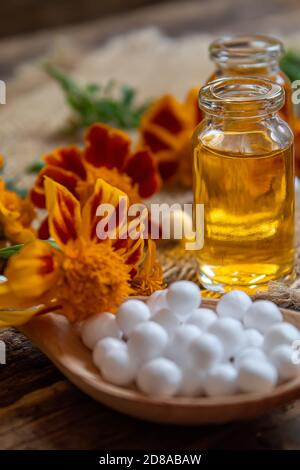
left=81, top=281, right=300, bottom=397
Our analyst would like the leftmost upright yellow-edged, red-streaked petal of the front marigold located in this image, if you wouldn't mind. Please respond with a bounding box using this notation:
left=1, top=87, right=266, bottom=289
left=45, top=177, right=81, bottom=251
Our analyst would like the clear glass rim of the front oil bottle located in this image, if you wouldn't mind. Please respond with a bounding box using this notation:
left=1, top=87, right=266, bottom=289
left=199, top=76, right=285, bottom=118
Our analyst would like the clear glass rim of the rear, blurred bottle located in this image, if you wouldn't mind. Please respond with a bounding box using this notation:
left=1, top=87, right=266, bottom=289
left=209, top=35, right=284, bottom=66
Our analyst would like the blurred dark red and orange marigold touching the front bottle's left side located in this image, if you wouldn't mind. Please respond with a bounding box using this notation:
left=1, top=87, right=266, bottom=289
left=140, top=88, right=201, bottom=186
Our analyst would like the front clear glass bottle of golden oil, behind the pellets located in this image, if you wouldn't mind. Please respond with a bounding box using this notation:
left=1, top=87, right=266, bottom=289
left=193, top=77, right=295, bottom=292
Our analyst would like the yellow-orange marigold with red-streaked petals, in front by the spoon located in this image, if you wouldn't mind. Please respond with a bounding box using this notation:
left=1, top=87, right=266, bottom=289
left=0, top=177, right=163, bottom=326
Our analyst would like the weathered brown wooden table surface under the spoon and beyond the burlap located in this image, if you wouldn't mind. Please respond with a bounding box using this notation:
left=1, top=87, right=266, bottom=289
left=0, top=0, right=300, bottom=450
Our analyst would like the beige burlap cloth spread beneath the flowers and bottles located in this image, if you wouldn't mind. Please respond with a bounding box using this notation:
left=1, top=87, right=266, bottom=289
left=0, top=29, right=300, bottom=310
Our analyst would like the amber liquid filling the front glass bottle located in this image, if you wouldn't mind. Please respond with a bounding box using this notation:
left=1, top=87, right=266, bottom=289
left=194, top=133, right=294, bottom=292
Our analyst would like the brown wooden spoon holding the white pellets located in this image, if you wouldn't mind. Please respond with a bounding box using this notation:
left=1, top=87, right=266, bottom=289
left=22, top=299, right=300, bottom=425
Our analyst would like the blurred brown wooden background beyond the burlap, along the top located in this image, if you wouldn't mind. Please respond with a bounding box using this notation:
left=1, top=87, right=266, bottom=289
left=0, top=0, right=300, bottom=78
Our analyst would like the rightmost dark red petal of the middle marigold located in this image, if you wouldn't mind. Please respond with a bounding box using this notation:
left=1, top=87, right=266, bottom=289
left=125, top=149, right=161, bottom=198
